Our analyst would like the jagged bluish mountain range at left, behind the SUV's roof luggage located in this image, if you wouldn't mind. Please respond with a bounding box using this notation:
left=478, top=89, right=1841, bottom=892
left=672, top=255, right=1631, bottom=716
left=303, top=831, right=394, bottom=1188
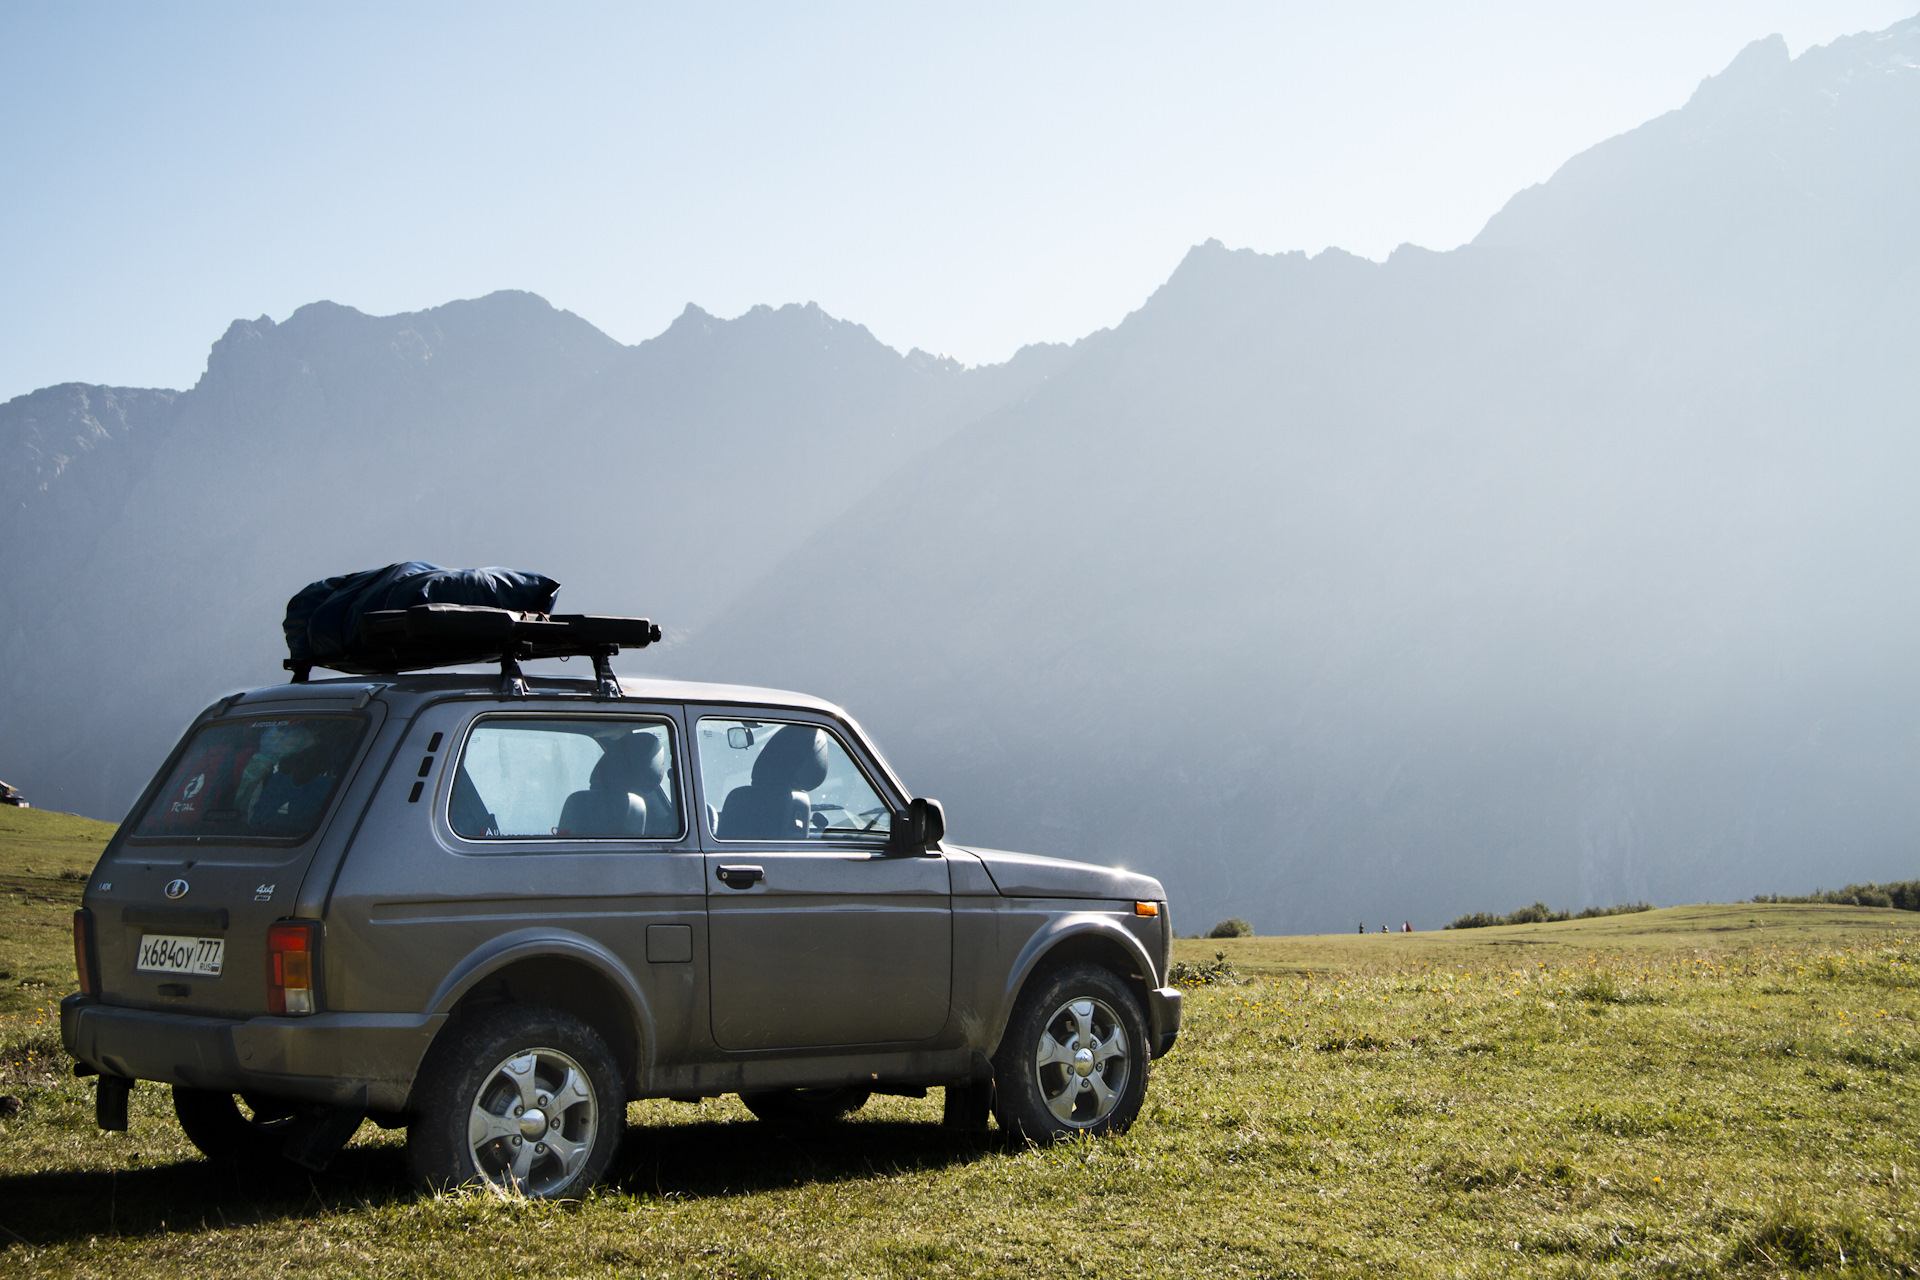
left=0, top=294, right=1068, bottom=818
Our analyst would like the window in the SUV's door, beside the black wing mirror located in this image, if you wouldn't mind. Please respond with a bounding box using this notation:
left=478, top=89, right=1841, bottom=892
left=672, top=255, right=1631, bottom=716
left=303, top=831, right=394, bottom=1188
left=699, top=718, right=893, bottom=842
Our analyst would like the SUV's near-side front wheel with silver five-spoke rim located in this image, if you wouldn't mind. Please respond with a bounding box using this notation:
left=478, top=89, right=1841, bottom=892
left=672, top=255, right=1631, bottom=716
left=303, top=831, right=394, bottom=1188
left=993, top=965, right=1148, bottom=1142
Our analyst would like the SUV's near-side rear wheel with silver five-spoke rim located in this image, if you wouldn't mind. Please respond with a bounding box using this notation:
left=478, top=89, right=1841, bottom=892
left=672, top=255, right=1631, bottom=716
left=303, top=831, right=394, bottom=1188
left=407, top=1007, right=626, bottom=1199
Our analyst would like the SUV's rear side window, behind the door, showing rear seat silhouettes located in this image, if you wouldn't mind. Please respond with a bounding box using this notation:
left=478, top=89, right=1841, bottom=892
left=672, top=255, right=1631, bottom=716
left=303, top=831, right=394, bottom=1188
left=447, top=716, right=685, bottom=841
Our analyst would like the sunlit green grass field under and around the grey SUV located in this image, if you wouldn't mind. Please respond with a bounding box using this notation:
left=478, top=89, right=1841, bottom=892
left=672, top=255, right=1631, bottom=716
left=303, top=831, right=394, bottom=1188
left=0, top=810, right=1920, bottom=1280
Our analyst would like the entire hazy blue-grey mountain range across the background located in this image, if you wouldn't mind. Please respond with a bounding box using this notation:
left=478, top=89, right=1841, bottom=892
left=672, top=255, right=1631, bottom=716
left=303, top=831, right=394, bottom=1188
left=0, top=19, right=1920, bottom=931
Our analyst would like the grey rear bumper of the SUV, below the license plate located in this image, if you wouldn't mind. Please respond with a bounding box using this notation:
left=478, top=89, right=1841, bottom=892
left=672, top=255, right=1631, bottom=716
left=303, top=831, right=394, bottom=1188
left=60, top=996, right=445, bottom=1111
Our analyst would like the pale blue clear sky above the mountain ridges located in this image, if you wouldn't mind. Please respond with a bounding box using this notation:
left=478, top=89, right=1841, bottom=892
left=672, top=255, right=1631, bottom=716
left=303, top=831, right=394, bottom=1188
left=0, top=0, right=1916, bottom=399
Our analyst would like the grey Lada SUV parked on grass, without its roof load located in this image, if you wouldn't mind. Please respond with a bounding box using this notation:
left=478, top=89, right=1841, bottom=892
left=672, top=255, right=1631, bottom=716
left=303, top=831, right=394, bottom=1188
left=61, top=662, right=1181, bottom=1196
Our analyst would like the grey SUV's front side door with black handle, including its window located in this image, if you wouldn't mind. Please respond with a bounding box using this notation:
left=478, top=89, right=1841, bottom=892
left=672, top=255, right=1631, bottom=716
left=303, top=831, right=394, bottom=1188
left=689, top=708, right=952, bottom=1052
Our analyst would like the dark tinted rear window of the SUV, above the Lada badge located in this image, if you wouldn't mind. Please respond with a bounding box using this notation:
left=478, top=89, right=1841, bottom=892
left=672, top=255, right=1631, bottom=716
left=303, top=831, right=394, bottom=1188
left=132, top=716, right=367, bottom=844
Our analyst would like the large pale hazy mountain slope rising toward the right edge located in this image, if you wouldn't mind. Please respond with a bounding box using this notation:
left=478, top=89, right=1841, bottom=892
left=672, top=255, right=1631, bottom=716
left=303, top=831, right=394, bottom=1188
left=685, top=12, right=1920, bottom=929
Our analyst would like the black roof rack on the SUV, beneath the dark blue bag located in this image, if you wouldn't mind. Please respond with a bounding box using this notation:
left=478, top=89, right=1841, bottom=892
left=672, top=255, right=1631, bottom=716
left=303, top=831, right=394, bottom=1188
left=280, top=604, right=660, bottom=699
